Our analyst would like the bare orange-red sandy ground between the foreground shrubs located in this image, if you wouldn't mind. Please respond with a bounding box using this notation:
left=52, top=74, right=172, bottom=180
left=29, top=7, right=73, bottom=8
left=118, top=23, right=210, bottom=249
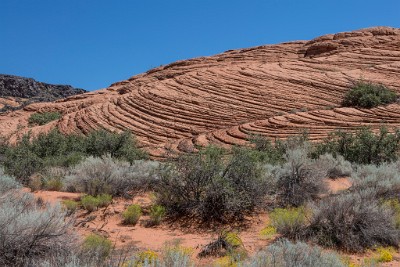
left=35, top=178, right=400, bottom=266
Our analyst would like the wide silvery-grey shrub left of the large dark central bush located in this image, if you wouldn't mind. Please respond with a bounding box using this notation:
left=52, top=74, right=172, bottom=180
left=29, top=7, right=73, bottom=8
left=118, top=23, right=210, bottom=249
left=65, top=156, right=159, bottom=196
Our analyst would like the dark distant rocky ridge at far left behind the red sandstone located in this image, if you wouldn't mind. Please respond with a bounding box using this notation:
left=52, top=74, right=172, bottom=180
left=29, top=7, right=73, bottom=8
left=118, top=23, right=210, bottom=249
left=0, top=74, right=86, bottom=109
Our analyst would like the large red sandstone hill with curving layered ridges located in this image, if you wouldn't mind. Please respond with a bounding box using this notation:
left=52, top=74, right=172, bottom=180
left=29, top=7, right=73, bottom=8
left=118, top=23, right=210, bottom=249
left=0, top=27, right=400, bottom=157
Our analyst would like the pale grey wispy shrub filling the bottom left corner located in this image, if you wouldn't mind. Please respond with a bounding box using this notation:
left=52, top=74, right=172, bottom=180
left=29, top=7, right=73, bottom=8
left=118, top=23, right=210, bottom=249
left=0, top=187, right=75, bottom=266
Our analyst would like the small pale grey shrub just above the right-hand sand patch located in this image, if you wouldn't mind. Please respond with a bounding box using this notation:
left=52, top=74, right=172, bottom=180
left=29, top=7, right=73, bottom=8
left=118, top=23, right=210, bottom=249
left=316, top=154, right=353, bottom=179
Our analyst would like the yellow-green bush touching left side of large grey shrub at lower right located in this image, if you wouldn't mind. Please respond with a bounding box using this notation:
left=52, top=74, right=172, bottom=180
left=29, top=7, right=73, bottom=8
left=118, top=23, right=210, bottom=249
left=270, top=207, right=307, bottom=239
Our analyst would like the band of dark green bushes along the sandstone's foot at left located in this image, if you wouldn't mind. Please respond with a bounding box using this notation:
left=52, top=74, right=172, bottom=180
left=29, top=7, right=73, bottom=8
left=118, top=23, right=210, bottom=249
left=0, top=130, right=147, bottom=185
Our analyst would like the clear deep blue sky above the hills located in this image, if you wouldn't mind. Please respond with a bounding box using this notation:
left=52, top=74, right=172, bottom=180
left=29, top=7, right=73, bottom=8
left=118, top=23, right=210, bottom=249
left=0, top=0, right=400, bottom=90
